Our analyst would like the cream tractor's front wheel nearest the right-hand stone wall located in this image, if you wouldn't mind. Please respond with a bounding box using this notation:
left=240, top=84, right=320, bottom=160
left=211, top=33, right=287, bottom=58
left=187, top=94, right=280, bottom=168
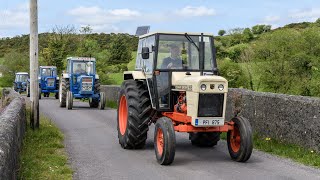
left=227, top=117, right=253, bottom=162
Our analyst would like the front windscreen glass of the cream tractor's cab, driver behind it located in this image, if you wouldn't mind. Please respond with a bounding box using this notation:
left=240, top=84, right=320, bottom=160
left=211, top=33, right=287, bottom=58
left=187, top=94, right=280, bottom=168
left=157, top=35, right=213, bottom=71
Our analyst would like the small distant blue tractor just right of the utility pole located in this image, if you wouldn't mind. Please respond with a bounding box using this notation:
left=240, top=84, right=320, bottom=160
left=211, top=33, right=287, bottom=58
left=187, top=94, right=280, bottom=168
left=38, top=66, right=59, bottom=99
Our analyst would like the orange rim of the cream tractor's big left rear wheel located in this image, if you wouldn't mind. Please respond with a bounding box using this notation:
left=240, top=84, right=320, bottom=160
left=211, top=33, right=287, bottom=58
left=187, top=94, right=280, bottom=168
left=119, top=96, right=128, bottom=135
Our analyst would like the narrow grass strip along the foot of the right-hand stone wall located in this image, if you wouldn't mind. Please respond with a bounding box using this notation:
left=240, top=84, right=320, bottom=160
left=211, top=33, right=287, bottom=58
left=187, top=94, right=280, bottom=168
left=220, top=133, right=320, bottom=168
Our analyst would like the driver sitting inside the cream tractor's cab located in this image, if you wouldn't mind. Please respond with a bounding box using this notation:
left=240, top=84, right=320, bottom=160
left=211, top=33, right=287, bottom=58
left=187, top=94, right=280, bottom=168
left=161, top=45, right=182, bottom=69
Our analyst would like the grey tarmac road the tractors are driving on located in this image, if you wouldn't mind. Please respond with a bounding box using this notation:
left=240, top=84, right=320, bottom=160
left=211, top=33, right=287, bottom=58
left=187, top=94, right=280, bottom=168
left=40, top=98, right=320, bottom=180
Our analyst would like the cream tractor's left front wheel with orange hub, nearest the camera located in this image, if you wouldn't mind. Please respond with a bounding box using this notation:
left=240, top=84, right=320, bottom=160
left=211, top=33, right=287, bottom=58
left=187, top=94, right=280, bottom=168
left=154, top=117, right=176, bottom=165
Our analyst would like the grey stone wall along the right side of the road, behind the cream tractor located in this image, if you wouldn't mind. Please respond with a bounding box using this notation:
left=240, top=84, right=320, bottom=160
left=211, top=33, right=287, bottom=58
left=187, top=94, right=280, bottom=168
left=102, top=86, right=320, bottom=151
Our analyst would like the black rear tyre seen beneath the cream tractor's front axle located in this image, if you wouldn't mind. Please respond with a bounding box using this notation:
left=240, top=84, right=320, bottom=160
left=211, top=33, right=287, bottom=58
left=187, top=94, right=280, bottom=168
left=189, top=132, right=220, bottom=147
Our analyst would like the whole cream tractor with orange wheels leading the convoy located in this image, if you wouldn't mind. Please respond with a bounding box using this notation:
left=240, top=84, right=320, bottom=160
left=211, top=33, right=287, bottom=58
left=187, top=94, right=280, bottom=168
left=117, top=33, right=253, bottom=165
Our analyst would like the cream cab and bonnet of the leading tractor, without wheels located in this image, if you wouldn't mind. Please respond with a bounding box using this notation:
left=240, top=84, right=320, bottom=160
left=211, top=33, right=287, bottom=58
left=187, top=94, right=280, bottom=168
left=125, top=33, right=228, bottom=119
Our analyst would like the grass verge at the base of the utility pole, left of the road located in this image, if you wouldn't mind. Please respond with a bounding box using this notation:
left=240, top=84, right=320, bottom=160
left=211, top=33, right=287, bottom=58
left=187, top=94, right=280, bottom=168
left=19, top=109, right=73, bottom=179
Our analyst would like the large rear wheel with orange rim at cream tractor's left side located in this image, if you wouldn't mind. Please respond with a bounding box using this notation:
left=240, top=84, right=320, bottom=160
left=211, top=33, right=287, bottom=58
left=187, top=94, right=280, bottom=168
left=117, top=80, right=153, bottom=149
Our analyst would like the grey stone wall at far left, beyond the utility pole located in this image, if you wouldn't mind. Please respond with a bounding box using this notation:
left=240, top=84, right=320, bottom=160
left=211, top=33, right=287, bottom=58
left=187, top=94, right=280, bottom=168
left=0, top=90, right=26, bottom=179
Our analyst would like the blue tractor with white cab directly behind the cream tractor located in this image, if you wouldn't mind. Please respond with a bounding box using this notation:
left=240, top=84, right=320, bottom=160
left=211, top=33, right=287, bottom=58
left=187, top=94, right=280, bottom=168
left=59, top=57, right=106, bottom=109
